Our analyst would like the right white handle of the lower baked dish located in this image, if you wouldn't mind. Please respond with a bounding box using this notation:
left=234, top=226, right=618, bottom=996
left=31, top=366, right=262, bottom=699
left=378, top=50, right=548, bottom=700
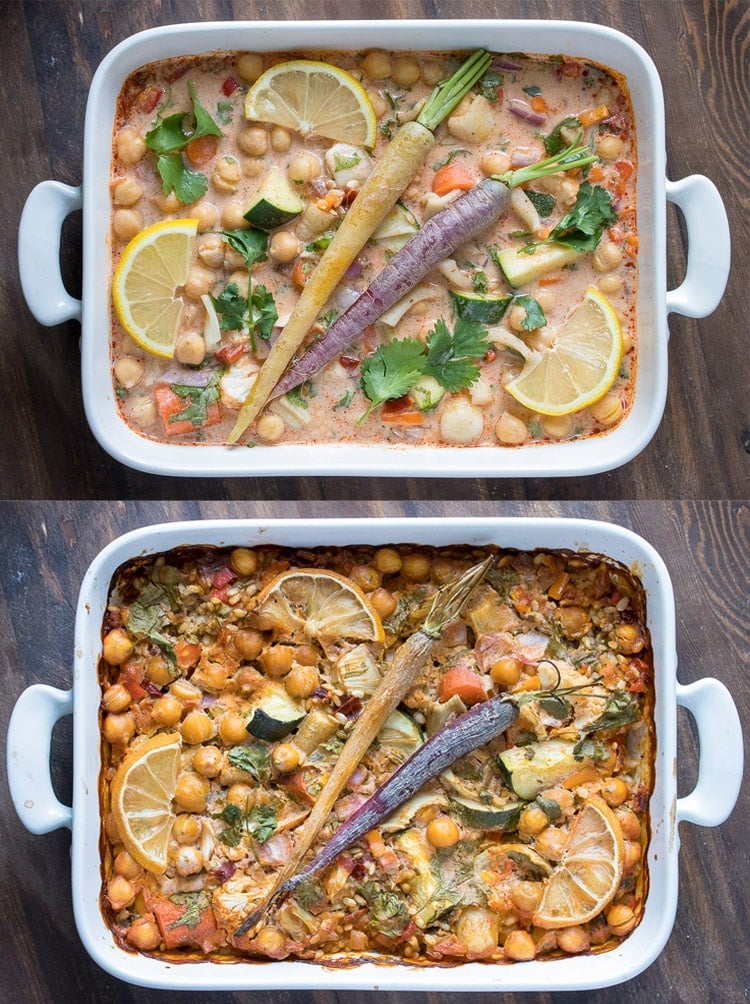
left=677, top=679, right=743, bottom=826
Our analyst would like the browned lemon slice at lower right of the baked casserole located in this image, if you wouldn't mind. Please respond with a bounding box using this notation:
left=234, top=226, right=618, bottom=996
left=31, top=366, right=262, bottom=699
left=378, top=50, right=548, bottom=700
left=533, top=798, right=624, bottom=929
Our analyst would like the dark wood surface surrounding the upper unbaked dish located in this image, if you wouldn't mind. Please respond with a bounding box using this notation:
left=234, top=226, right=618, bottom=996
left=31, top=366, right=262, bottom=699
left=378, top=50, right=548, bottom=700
left=0, top=0, right=750, bottom=501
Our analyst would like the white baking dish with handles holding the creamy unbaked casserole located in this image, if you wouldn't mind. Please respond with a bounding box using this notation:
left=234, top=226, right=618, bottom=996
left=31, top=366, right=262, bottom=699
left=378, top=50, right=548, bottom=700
left=19, top=20, right=730, bottom=477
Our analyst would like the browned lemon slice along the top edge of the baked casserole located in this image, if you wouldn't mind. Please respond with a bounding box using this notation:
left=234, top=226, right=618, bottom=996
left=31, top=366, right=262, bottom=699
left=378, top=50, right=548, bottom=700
left=256, top=568, right=385, bottom=642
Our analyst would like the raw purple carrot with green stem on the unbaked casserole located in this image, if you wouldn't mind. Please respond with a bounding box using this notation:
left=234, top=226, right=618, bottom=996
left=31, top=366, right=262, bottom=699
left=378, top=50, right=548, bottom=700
left=271, top=146, right=597, bottom=398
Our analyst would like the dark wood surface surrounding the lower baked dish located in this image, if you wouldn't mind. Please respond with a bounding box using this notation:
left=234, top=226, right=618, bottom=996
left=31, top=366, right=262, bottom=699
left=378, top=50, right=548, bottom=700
left=0, top=501, right=750, bottom=1004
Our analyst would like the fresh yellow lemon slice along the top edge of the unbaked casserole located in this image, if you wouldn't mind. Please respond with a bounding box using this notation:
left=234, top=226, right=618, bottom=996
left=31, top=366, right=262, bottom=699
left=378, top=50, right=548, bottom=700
left=245, top=59, right=378, bottom=148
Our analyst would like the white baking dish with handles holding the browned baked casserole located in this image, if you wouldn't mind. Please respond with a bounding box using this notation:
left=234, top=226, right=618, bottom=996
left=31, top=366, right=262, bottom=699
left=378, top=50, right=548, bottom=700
left=7, top=519, right=743, bottom=992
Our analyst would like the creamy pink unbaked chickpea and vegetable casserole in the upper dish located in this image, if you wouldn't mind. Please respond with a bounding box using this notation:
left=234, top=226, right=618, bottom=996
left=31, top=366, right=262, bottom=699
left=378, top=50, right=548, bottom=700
left=110, top=50, right=638, bottom=448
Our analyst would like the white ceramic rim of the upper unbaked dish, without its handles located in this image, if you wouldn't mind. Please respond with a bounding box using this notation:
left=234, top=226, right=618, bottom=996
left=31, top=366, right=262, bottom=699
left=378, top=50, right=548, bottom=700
left=81, top=19, right=669, bottom=477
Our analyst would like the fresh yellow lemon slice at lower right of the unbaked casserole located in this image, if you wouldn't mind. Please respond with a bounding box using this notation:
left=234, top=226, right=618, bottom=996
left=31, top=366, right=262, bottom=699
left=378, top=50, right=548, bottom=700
left=505, top=287, right=623, bottom=415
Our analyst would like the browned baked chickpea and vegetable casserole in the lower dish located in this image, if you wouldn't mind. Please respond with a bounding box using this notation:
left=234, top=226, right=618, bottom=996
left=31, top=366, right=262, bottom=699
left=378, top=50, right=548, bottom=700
left=100, top=544, right=655, bottom=965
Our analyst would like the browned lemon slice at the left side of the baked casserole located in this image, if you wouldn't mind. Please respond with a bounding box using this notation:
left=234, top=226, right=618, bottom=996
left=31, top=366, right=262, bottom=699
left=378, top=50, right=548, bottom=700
left=110, top=732, right=182, bottom=874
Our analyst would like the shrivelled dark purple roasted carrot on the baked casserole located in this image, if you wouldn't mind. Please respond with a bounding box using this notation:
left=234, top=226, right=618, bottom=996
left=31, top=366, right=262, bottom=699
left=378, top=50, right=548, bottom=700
left=236, top=696, right=518, bottom=935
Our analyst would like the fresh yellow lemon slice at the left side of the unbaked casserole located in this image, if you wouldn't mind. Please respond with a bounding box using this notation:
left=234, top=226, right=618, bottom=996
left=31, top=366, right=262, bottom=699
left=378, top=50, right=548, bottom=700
left=112, top=220, right=198, bottom=358
